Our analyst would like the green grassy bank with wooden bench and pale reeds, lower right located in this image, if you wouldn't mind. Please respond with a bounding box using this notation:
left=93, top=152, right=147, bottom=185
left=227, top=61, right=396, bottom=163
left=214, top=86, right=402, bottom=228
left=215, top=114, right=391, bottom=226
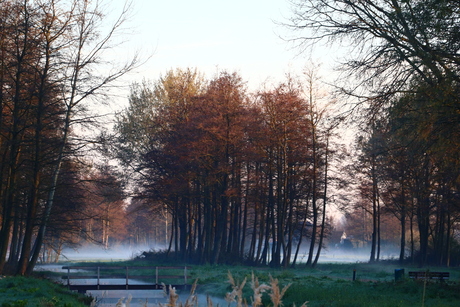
left=28, top=260, right=460, bottom=307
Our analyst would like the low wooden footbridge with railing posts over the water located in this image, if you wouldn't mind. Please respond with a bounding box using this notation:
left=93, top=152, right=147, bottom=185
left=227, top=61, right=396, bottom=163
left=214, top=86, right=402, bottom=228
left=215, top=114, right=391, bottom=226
left=62, top=266, right=190, bottom=293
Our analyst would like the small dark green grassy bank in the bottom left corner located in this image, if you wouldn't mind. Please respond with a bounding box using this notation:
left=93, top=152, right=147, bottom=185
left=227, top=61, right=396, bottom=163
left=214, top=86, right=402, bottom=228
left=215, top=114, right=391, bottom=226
left=0, top=276, right=92, bottom=307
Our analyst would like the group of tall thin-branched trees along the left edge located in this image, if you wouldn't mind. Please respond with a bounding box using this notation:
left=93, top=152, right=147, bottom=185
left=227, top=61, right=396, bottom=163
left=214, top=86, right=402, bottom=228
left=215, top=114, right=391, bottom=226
left=0, top=0, right=137, bottom=275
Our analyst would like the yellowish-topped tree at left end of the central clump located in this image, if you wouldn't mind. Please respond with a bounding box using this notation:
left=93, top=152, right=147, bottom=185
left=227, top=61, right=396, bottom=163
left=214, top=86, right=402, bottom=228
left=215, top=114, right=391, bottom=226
left=115, top=69, right=210, bottom=257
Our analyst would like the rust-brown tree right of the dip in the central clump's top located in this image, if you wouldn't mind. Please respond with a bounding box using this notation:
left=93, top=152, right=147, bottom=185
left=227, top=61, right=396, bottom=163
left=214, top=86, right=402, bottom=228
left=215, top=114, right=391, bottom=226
left=259, top=78, right=320, bottom=267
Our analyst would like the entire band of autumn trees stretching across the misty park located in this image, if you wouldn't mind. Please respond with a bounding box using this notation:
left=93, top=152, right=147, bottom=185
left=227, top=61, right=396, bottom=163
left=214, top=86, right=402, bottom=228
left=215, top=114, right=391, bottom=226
left=0, top=0, right=460, bottom=275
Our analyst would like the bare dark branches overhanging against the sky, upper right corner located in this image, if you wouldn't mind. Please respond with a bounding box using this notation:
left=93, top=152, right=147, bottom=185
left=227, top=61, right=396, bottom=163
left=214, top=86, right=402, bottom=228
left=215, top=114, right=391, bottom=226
left=289, top=0, right=460, bottom=102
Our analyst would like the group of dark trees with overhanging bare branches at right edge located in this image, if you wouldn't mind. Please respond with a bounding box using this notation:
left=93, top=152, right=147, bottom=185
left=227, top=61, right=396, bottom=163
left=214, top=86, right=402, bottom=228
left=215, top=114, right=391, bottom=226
left=288, top=0, right=460, bottom=266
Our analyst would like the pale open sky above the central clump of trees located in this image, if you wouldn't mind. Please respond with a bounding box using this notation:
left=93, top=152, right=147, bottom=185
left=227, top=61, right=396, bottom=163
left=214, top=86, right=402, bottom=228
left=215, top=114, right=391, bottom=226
left=110, top=0, right=334, bottom=91
